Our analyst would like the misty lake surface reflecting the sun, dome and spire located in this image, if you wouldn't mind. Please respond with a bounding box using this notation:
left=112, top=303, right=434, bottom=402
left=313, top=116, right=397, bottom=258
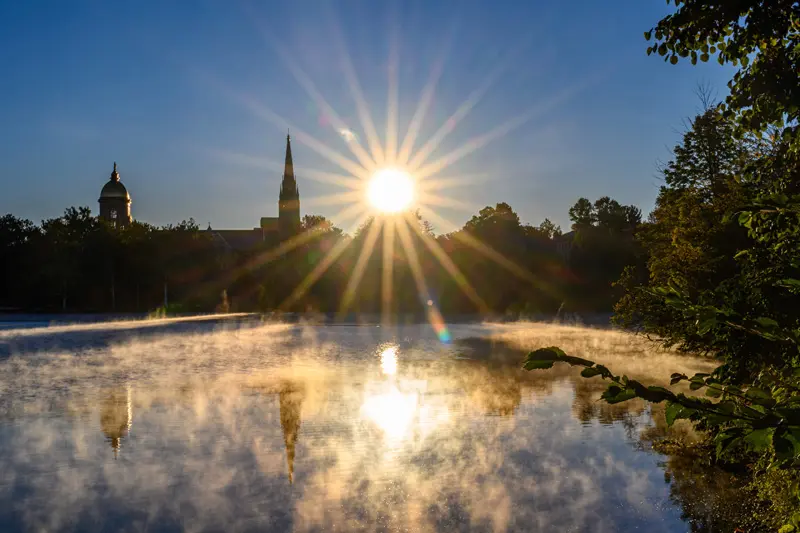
left=0, top=319, right=736, bottom=532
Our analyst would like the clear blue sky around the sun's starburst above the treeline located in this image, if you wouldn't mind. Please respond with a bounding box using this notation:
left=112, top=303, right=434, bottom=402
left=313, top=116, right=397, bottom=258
left=0, top=0, right=731, bottom=231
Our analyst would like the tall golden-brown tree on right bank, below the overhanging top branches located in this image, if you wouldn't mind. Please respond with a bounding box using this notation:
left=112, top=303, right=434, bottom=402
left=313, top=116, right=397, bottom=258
left=615, top=107, right=749, bottom=351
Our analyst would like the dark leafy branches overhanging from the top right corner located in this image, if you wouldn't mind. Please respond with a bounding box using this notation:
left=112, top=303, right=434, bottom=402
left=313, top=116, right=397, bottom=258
left=645, top=0, right=800, bottom=140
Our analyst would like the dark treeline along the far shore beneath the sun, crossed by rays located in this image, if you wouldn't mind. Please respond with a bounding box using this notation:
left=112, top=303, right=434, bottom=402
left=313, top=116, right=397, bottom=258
left=0, top=197, right=641, bottom=317
